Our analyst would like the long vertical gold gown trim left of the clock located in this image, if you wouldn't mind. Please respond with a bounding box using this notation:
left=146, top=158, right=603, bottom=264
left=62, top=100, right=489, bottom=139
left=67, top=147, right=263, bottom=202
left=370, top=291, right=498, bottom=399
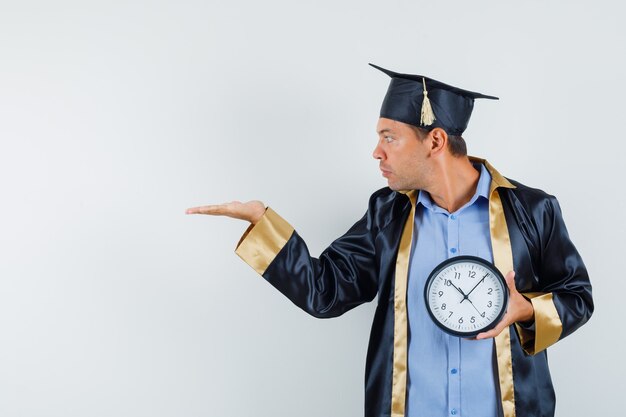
left=391, top=190, right=417, bottom=417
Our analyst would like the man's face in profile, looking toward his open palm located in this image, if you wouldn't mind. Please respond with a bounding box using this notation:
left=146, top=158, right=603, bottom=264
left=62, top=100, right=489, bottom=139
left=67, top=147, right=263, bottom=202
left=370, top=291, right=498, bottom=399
left=372, top=117, right=432, bottom=190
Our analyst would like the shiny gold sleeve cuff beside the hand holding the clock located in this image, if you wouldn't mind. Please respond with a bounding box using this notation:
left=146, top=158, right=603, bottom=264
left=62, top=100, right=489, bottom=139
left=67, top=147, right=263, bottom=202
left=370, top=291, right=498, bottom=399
left=516, top=293, right=563, bottom=355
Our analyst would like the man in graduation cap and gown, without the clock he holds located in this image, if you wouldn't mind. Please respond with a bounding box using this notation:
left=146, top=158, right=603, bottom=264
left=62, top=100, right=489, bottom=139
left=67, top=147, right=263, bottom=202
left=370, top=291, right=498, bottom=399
left=187, top=66, right=593, bottom=417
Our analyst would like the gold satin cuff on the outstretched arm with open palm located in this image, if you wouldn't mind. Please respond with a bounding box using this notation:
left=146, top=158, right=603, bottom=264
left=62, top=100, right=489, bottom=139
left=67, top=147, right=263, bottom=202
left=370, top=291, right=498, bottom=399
left=235, top=207, right=294, bottom=275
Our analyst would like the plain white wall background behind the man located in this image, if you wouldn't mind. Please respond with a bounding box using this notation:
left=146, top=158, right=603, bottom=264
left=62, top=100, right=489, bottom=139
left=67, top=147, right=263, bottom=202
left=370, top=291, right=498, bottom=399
left=0, top=0, right=626, bottom=417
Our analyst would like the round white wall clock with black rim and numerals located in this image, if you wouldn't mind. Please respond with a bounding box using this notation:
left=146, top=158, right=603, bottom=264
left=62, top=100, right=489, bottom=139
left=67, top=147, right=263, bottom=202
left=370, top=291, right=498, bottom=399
left=424, top=256, right=509, bottom=337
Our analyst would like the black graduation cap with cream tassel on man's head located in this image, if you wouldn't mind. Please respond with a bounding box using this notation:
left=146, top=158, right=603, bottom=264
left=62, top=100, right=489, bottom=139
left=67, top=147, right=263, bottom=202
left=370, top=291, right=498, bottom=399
left=370, top=64, right=498, bottom=136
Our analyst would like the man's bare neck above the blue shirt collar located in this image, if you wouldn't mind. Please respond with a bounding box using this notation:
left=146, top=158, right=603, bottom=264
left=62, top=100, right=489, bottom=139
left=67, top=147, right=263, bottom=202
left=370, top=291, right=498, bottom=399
left=426, top=156, right=480, bottom=213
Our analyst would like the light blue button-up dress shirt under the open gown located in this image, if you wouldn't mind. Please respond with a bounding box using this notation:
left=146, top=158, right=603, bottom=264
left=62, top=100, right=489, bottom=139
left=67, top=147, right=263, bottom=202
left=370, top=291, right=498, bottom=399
left=406, top=164, right=500, bottom=417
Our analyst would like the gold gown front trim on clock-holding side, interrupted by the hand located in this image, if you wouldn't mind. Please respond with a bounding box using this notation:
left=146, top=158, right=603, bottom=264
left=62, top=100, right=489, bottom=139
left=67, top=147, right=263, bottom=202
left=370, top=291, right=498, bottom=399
left=489, top=187, right=515, bottom=417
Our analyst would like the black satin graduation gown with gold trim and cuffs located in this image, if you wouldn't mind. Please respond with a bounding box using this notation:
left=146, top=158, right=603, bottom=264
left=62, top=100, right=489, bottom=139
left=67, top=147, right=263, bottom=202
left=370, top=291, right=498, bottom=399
left=236, top=157, right=593, bottom=417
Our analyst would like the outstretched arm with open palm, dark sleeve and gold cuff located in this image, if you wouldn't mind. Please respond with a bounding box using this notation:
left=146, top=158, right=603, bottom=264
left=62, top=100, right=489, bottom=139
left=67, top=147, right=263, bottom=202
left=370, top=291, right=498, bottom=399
left=187, top=197, right=378, bottom=318
